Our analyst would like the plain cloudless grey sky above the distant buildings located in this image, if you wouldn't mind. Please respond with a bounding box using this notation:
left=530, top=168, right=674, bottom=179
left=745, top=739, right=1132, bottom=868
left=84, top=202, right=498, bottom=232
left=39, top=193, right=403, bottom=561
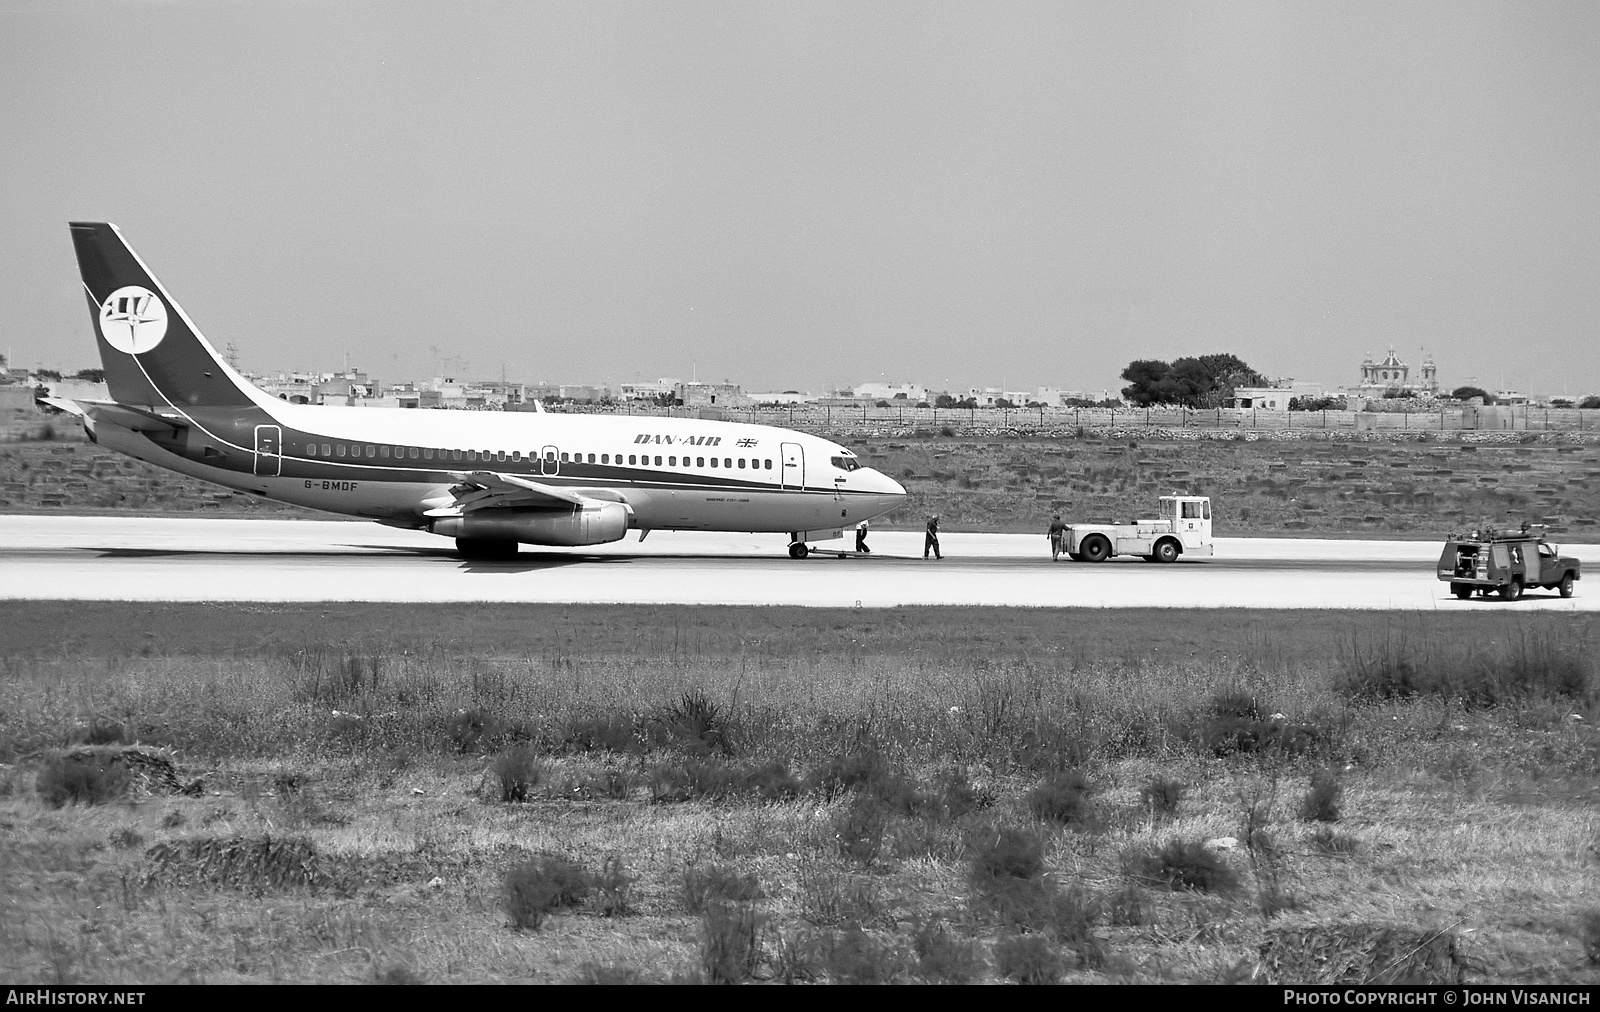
left=0, top=0, right=1600, bottom=394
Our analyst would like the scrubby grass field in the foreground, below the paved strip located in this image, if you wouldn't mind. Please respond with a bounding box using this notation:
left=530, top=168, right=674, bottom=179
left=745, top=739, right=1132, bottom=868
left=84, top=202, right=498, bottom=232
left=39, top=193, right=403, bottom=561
left=0, top=602, right=1600, bottom=985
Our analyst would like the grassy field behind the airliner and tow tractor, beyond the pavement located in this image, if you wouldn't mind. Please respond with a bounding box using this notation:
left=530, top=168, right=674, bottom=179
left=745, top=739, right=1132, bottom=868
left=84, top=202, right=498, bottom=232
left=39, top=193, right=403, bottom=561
left=0, top=401, right=1600, bottom=541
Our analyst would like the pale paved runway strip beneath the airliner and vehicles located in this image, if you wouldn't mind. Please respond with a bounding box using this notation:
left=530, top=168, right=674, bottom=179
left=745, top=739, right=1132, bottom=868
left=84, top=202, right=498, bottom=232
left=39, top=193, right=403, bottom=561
left=0, top=516, right=1600, bottom=612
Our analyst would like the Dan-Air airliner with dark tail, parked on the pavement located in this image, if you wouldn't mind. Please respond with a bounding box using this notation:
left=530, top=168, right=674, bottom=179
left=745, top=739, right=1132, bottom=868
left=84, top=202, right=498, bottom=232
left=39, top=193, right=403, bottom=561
left=45, top=221, right=906, bottom=559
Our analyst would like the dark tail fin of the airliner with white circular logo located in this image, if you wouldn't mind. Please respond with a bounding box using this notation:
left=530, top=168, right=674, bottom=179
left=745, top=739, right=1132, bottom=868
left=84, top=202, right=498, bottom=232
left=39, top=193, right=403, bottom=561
left=70, top=221, right=254, bottom=408
